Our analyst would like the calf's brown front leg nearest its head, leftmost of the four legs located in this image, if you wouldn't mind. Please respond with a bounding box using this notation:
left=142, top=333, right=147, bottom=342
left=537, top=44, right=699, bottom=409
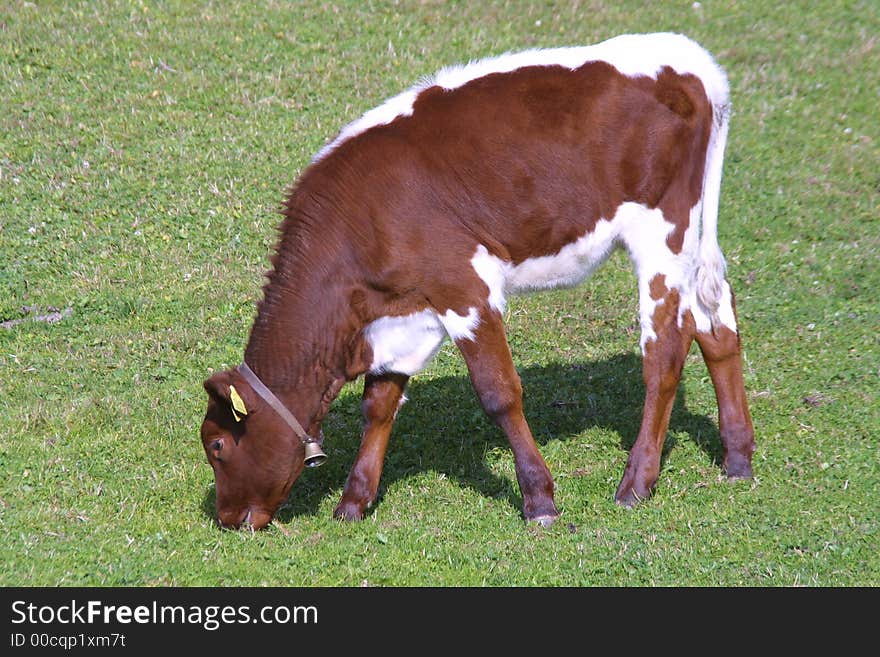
left=333, top=372, right=409, bottom=520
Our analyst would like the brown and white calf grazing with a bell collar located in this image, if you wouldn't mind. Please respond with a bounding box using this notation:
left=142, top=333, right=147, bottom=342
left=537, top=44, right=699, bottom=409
left=202, top=34, right=754, bottom=528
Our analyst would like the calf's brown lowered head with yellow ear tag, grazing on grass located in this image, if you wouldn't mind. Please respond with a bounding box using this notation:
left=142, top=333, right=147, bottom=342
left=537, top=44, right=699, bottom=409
left=201, top=370, right=305, bottom=529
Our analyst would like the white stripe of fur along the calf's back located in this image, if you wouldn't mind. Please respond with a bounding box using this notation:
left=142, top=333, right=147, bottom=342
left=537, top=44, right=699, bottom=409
left=313, top=32, right=729, bottom=161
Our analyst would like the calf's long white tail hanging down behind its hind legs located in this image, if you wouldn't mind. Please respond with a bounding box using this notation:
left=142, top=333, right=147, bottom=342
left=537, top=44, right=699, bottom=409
left=696, top=103, right=730, bottom=332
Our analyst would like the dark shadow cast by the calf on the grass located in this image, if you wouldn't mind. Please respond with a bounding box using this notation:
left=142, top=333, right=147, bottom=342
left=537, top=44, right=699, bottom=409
left=202, top=354, right=722, bottom=523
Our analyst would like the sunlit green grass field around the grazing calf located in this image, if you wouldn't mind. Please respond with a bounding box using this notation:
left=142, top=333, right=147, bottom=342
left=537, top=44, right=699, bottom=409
left=0, top=0, right=880, bottom=586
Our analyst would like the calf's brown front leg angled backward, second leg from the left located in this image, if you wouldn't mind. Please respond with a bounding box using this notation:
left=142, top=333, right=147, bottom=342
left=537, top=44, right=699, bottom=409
left=455, top=307, right=559, bottom=527
